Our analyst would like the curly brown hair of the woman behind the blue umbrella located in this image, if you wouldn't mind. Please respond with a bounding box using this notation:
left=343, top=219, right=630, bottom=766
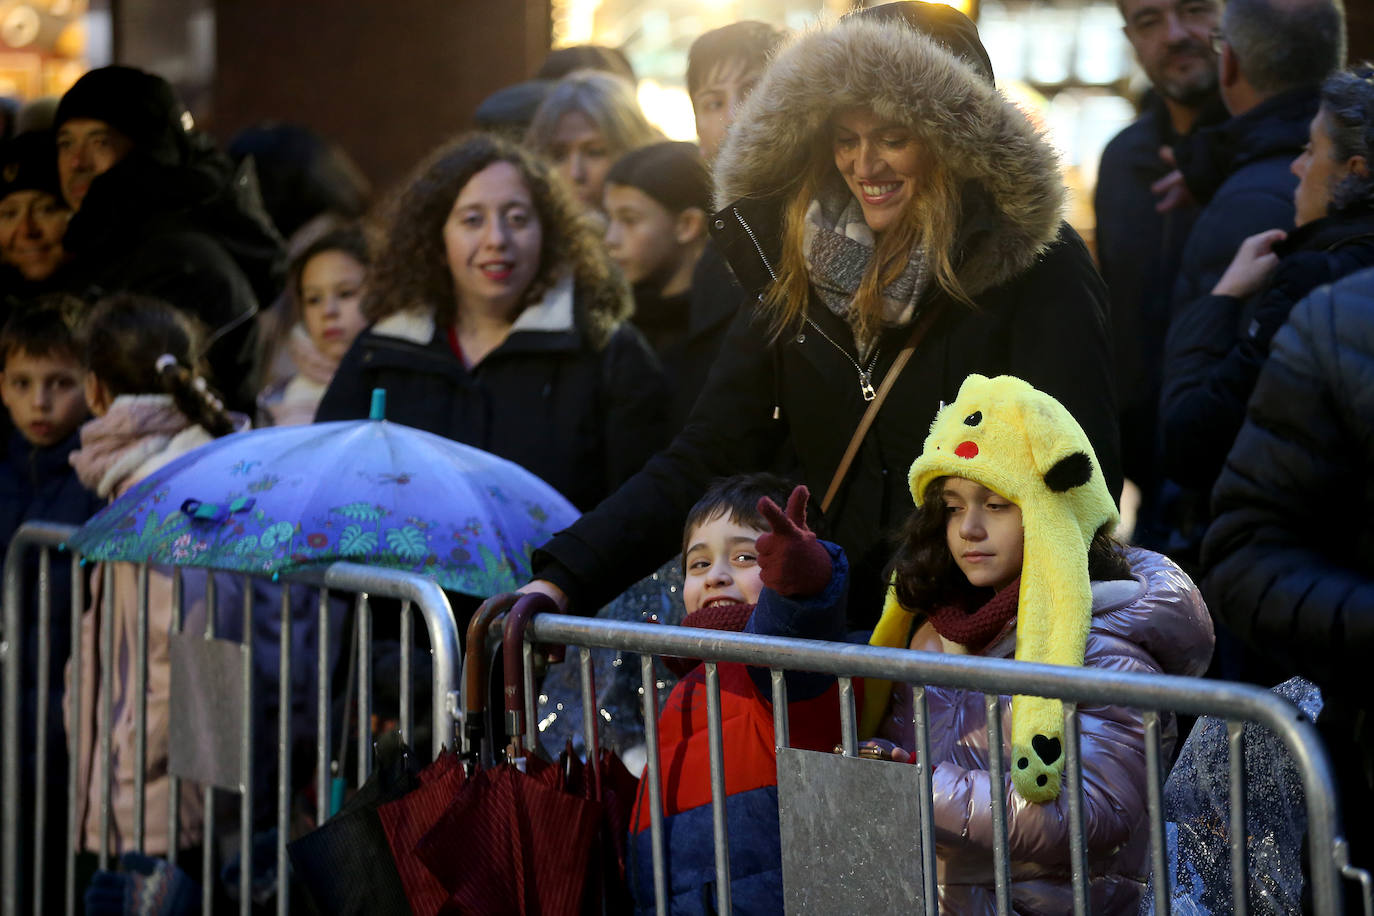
left=363, top=133, right=631, bottom=336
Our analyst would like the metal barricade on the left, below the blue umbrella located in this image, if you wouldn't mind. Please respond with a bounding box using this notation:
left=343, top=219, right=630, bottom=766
left=0, top=522, right=460, bottom=916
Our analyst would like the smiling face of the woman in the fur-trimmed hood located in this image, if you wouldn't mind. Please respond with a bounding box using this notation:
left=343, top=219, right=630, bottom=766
left=831, top=108, right=922, bottom=232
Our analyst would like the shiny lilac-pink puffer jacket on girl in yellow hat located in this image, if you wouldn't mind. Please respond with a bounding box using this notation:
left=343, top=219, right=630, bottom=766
left=879, top=548, right=1213, bottom=916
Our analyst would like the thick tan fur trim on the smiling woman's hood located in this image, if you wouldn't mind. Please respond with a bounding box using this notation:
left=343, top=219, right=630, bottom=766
left=714, top=16, right=1065, bottom=295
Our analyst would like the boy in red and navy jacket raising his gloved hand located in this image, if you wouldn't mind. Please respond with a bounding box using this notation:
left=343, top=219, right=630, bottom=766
left=631, top=474, right=849, bottom=913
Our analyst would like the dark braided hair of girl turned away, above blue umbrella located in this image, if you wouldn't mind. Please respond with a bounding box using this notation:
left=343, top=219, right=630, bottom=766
left=81, top=293, right=234, bottom=437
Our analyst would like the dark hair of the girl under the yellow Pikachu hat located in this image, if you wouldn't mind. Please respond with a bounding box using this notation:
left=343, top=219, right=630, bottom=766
left=885, top=477, right=1131, bottom=612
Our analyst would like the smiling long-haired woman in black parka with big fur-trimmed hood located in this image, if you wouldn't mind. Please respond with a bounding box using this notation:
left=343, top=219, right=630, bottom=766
left=524, top=3, right=1121, bottom=628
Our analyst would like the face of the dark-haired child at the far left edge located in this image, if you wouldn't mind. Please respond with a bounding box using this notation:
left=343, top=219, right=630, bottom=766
left=0, top=350, right=87, bottom=448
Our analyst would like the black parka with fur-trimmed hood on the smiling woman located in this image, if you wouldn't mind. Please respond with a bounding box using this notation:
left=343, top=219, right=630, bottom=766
left=534, top=21, right=1121, bottom=628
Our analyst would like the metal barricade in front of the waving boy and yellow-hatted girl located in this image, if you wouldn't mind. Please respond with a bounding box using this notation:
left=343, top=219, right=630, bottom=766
left=515, top=614, right=1370, bottom=916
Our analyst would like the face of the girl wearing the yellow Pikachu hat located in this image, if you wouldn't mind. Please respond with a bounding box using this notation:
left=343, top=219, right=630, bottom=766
left=943, top=477, right=1025, bottom=591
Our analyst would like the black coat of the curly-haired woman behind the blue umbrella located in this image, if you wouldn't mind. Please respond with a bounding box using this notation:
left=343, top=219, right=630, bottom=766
left=315, top=302, right=668, bottom=509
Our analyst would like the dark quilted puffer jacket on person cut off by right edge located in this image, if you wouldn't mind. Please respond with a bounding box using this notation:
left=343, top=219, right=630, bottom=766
left=1202, top=269, right=1374, bottom=895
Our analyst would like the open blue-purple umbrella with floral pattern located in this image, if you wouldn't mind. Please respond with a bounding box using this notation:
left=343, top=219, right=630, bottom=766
left=71, top=395, right=577, bottom=597
